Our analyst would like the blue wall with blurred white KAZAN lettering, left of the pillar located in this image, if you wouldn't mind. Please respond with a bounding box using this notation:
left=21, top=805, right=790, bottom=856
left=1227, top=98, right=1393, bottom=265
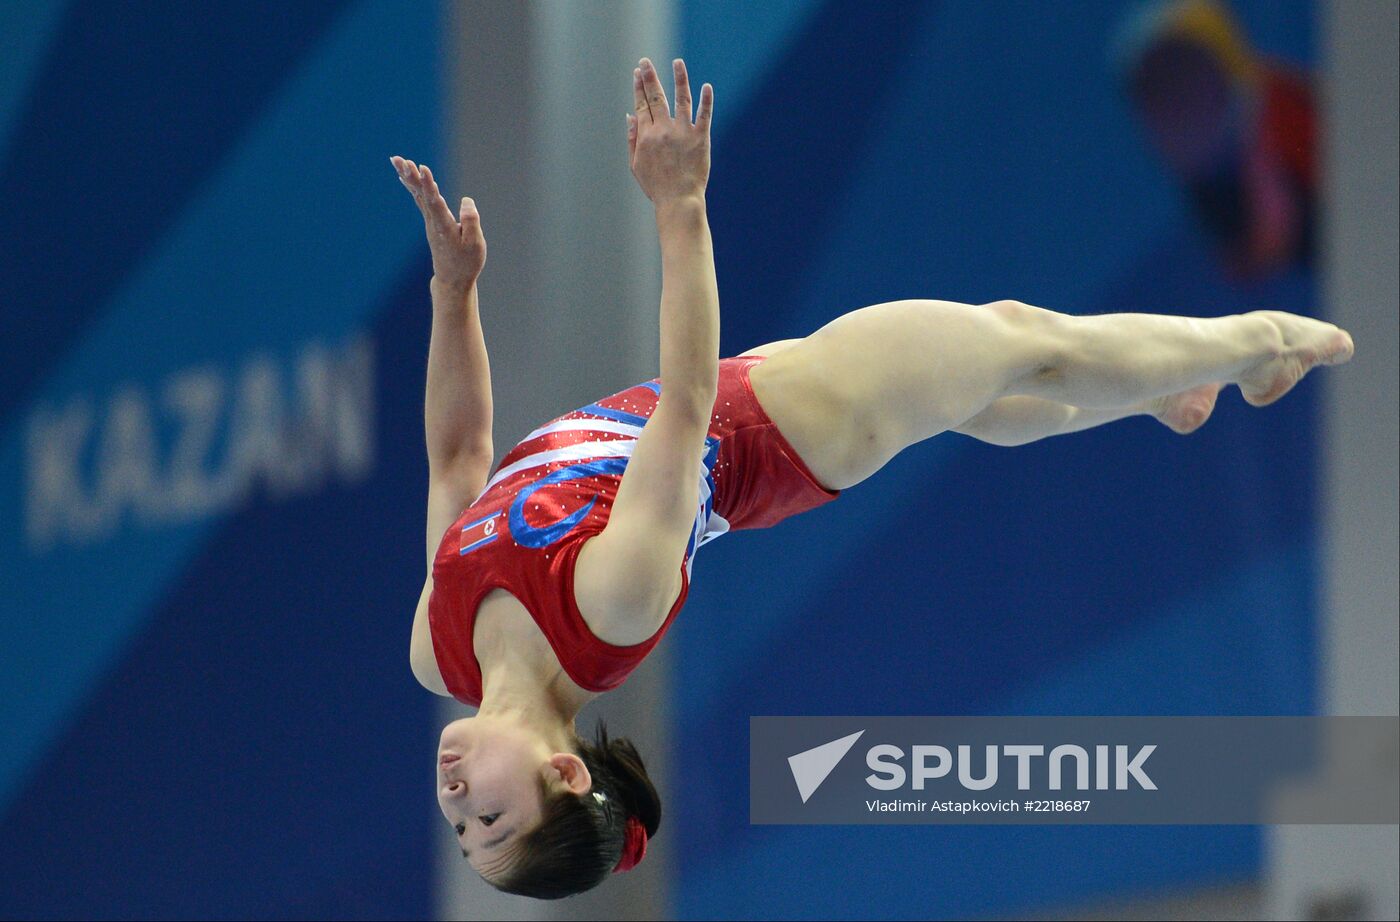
left=0, top=0, right=440, bottom=918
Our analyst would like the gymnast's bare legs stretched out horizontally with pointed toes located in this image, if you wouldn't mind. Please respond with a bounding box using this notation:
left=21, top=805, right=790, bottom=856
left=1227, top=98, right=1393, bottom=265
left=752, top=299, right=1352, bottom=490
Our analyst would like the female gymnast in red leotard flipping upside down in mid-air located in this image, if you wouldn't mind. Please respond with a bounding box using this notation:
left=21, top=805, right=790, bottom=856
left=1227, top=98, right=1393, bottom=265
left=391, top=59, right=1352, bottom=898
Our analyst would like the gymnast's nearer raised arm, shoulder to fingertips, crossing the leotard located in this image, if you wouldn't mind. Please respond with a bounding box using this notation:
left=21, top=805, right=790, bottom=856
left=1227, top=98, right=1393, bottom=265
left=574, top=59, right=720, bottom=644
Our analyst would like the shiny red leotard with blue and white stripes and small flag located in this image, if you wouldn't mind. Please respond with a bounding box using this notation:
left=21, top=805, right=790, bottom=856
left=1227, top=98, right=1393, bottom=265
left=428, top=355, right=839, bottom=707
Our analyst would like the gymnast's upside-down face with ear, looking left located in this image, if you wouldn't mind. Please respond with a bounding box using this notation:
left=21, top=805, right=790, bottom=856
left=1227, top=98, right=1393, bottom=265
left=437, top=716, right=578, bottom=877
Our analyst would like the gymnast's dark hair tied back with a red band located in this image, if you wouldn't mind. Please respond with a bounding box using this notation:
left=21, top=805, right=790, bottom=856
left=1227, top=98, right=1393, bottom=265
left=486, top=719, right=661, bottom=900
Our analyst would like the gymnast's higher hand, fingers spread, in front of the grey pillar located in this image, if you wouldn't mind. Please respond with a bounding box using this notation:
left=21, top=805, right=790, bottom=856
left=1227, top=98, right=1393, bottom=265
left=627, top=57, right=714, bottom=204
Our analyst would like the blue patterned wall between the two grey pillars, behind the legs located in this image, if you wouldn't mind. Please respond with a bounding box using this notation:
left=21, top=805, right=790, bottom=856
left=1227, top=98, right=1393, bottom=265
left=669, top=1, right=1320, bottom=918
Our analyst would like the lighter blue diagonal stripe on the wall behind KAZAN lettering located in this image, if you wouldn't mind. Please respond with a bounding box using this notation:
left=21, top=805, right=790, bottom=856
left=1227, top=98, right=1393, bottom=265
left=0, top=0, right=437, bottom=809
